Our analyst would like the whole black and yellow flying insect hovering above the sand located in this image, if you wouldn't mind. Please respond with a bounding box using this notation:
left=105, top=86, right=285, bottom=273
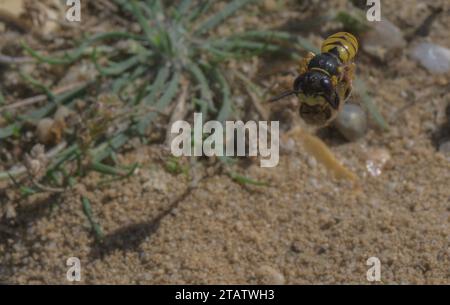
left=269, top=32, right=358, bottom=126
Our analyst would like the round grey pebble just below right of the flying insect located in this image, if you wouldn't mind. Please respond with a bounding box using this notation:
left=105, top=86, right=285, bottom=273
left=334, top=104, right=367, bottom=141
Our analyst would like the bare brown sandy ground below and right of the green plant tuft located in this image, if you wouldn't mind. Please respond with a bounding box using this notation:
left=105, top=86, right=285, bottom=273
left=0, top=1, right=450, bottom=284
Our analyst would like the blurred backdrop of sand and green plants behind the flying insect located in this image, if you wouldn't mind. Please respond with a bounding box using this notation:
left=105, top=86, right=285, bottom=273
left=0, top=0, right=450, bottom=284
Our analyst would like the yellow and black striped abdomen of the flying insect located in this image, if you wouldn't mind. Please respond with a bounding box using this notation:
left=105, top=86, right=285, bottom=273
left=321, top=32, right=358, bottom=63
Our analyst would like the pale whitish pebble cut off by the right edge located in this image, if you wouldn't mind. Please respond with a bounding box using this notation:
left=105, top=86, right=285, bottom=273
left=411, top=42, right=450, bottom=74
